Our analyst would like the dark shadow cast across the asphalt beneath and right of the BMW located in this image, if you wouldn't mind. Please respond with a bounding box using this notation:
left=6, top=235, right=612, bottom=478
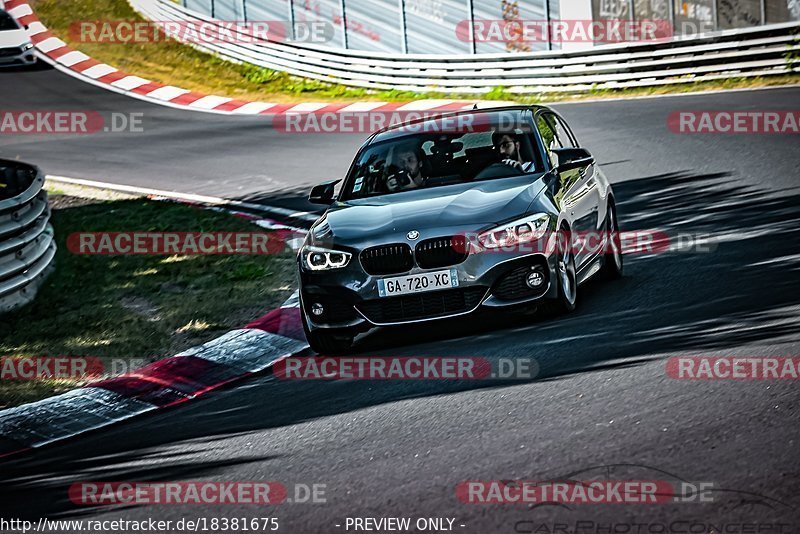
left=1, top=171, right=800, bottom=518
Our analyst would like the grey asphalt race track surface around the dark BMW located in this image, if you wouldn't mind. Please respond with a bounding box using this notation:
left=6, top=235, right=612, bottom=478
left=0, top=65, right=800, bottom=534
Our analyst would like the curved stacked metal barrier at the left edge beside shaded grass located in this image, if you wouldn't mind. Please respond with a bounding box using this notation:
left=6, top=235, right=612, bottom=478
left=0, top=159, right=56, bottom=313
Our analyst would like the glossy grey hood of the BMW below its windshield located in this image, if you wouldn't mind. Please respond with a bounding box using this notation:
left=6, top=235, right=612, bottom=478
left=312, top=175, right=544, bottom=243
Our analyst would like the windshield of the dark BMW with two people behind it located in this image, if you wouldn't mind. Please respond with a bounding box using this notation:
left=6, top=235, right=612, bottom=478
left=341, top=121, right=541, bottom=200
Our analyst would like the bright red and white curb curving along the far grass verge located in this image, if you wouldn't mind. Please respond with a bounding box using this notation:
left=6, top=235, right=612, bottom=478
left=5, top=0, right=476, bottom=115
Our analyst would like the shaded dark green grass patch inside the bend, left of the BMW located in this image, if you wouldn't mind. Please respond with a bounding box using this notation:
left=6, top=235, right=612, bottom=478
left=0, top=190, right=294, bottom=408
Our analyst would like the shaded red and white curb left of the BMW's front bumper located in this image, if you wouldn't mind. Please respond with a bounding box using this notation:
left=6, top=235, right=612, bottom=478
left=0, top=294, right=308, bottom=457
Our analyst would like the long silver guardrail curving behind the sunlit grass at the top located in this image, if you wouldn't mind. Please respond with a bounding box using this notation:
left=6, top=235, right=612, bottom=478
left=129, top=0, right=800, bottom=93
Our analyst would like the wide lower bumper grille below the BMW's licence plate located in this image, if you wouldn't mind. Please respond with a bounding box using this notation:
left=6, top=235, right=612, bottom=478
left=358, top=286, right=486, bottom=323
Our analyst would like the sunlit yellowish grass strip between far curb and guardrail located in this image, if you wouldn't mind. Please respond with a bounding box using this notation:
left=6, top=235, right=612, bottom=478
left=31, top=0, right=800, bottom=104
